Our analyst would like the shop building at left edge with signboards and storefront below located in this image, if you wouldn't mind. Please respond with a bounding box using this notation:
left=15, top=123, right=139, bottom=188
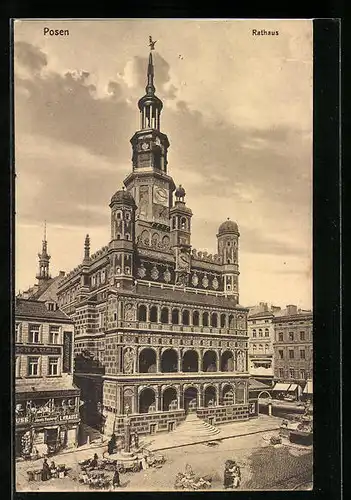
left=14, top=298, right=80, bottom=455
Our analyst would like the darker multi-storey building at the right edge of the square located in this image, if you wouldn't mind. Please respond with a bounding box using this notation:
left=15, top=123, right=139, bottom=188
left=273, top=305, right=313, bottom=395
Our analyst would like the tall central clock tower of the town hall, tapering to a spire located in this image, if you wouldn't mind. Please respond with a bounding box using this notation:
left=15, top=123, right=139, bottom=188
left=124, top=52, right=175, bottom=237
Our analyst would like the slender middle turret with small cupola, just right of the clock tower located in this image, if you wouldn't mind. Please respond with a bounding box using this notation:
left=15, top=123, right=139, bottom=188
left=170, top=185, right=193, bottom=286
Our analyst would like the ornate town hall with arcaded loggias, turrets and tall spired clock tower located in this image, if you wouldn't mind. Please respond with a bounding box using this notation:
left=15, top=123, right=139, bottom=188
left=53, top=47, right=249, bottom=433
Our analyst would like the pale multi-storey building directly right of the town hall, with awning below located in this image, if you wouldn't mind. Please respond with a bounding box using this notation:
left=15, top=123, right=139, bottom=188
left=247, top=302, right=281, bottom=385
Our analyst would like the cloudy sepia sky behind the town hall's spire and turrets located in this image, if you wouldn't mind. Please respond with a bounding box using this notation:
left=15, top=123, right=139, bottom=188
left=15, top=19, right=312, bottom=308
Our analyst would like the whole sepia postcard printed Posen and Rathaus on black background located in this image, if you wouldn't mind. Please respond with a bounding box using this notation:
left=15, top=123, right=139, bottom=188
left=13, top=19, right=313, bottom=493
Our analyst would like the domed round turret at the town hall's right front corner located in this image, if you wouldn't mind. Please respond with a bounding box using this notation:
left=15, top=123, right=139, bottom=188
left=217, top=217, right=240, bottom=303
